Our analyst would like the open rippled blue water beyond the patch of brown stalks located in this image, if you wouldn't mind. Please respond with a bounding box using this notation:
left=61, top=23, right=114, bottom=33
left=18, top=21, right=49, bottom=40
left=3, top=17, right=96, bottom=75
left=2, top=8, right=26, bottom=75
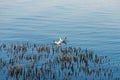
left=0, top=0, right=120, bottom=78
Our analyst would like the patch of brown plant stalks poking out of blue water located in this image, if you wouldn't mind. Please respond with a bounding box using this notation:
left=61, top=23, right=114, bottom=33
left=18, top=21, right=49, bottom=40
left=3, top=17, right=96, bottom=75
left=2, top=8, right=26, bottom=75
left=0, top=43, right=119, bottom=80
